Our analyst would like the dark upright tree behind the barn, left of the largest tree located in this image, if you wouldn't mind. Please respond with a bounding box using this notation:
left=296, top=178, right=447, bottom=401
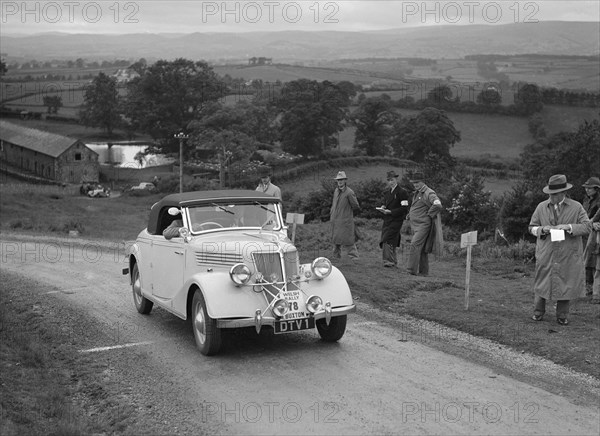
left=79, top=73, right=121, bottom=135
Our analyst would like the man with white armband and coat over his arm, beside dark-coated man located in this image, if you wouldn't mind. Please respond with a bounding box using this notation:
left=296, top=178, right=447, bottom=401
left=407, top=172, right=442, bottom=276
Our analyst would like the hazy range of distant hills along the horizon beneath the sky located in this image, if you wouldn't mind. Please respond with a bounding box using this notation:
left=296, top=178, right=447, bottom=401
left=2, top=21, right=600, bottom=62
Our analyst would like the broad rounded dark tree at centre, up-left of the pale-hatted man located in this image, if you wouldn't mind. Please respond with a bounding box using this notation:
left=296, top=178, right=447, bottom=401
left=275, top=79, right=351, bottom=155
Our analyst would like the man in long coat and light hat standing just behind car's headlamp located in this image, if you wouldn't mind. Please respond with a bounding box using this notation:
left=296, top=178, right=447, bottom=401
left=330, top=171, right=360, bottom=260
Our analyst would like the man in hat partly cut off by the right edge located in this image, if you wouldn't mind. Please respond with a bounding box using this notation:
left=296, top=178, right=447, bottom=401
left=583, top=177, right=600, bottom=304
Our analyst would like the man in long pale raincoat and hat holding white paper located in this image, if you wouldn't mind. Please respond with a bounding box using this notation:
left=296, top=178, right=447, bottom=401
left=529, top=174, right=592, bottom=325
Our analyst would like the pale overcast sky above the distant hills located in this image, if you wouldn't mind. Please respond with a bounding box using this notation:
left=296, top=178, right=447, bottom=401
left=0, top=0, right=600, bottom=35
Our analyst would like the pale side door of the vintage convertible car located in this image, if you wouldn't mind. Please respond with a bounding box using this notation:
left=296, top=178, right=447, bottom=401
left=152, top=235, right=186, bottom=307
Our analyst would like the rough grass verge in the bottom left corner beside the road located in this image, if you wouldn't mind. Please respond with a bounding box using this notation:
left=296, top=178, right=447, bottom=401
left=0, top=271, right=138, bottom=436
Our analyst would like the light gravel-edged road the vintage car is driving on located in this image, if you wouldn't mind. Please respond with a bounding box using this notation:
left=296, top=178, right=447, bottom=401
left=1, top=234, right=600, bottom=435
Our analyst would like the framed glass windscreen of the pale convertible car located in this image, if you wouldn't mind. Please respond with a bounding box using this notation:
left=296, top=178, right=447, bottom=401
left=188, top=201, right=281, bottom=233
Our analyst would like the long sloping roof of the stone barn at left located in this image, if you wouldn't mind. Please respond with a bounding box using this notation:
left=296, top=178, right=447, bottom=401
left=0, top=120, right=97, bottom=157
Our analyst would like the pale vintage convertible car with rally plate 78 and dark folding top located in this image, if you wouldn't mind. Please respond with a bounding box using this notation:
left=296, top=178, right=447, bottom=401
left=123, top=190, right=356, bottom=355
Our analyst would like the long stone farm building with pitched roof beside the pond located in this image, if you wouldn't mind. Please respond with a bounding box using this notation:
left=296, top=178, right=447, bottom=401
left=0, top=120, right=100, bottom=183
